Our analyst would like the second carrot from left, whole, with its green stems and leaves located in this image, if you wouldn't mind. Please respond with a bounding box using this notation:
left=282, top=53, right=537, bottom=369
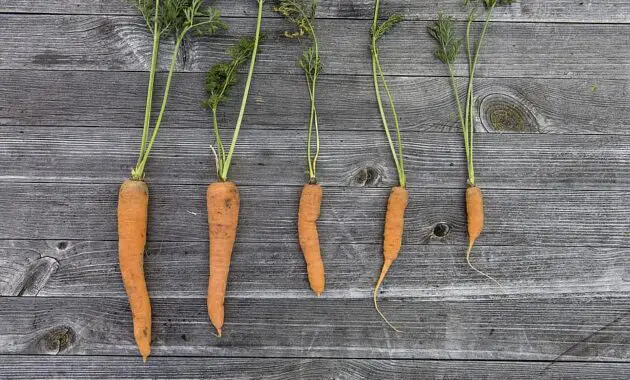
left=202, top=0, right=264, bottom=337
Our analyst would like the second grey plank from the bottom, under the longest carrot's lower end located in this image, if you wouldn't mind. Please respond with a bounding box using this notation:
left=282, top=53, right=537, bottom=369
left=0, top=296, right=630, bottom=362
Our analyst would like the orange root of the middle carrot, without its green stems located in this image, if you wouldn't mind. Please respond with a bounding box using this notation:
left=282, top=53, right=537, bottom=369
left=298, top=184, right=326, bottom=297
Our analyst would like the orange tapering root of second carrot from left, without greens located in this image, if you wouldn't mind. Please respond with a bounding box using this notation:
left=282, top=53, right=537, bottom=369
left=207, top=181, right=241, bottom=336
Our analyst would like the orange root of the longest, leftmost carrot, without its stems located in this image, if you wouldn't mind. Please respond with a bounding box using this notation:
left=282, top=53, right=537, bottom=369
left=118, top=180, right=151, bottom=362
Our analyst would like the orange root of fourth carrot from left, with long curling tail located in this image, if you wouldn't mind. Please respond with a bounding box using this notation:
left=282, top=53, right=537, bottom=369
left=374, top=186, right=409, bottom=331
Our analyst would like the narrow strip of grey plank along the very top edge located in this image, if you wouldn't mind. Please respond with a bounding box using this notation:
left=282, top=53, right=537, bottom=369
left=0, top=0, right=630, bottom=23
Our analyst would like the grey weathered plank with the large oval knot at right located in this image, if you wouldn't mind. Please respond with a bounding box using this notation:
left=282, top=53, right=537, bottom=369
left=0, top=71, right=630, bottom=138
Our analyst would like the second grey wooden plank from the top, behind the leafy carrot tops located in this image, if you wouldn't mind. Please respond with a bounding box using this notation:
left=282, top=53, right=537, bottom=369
left=0, top=14, right=630, bottom=79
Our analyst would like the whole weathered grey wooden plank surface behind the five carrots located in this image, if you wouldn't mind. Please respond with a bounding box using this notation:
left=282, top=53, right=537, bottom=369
left=0, top=0, right=630, bottom=380
